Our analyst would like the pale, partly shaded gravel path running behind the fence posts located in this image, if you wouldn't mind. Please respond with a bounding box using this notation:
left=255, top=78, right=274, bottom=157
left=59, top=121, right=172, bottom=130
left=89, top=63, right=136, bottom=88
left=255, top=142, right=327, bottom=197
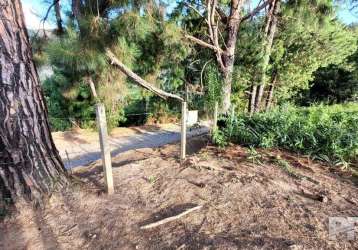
left=54, top=125, right=209, bottom=169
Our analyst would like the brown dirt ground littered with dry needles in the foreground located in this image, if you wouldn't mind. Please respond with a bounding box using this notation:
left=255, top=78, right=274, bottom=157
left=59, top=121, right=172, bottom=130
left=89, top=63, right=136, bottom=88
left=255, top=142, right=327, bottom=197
left=0, top=138, right=358, bottom=250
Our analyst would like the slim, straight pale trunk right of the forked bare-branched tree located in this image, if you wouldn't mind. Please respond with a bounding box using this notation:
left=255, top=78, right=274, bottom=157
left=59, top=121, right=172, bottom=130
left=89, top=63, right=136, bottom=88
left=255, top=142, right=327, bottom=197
left=254, top=0, right=280, bottom=112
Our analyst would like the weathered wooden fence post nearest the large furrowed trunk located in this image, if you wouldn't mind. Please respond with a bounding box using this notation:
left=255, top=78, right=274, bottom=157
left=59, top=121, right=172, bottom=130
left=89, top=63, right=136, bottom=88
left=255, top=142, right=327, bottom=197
left=96, top=103, right=114, bottom=194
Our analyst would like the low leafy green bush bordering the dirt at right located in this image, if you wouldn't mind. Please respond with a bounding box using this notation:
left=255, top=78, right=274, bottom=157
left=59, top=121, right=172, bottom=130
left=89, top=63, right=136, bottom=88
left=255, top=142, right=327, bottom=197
left=215, top=104, right=358, bottom=165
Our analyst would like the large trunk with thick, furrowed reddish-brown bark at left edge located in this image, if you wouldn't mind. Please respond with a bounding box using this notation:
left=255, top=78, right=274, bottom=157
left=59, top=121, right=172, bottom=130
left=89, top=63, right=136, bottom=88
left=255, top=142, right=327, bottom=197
left=0, top=0, right=68, bottom=201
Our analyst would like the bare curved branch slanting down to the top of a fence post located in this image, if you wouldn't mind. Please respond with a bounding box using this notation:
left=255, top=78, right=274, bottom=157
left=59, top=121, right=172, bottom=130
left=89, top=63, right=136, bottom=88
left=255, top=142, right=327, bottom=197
left=106, top=49, right=184, bottom=102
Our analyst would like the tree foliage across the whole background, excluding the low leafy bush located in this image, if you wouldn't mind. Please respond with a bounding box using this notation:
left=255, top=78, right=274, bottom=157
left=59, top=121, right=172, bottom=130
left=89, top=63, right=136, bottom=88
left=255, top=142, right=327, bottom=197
left=33, top=0, right=358, bottom=125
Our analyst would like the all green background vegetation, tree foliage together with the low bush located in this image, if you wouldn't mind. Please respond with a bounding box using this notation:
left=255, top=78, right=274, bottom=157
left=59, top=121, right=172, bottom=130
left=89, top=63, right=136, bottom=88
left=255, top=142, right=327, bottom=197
left=32, top=0, right=358, bottom=168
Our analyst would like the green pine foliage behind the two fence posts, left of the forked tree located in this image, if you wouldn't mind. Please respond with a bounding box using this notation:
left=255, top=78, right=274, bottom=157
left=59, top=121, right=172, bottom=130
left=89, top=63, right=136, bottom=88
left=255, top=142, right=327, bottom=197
left=34, top=1, right=189, bottom=130
